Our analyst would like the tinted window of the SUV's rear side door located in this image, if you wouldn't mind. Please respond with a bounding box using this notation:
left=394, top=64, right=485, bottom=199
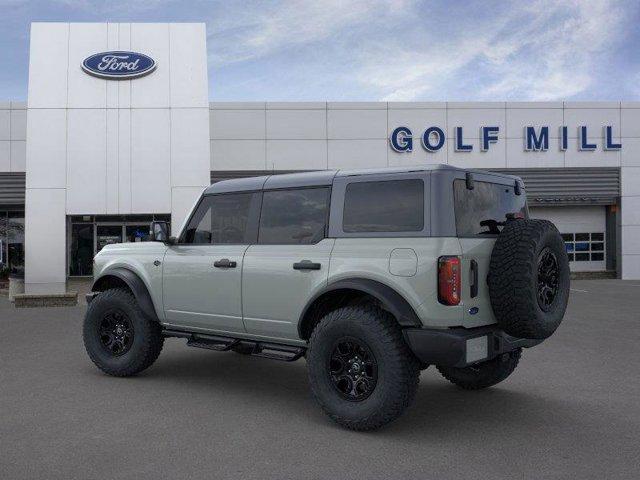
left=258, top=188, right=330, bottom=245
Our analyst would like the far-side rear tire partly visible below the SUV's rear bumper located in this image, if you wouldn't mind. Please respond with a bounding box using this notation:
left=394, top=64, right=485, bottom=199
left=437, top=348, right=522, bottom=390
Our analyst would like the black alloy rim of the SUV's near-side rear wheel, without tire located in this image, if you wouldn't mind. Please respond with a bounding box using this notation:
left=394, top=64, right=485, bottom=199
left=329, top=337, right=378, bottom=402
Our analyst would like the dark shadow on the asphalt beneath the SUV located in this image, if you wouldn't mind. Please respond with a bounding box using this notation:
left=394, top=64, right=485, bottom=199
left=112, top=342, right=596, bottom=440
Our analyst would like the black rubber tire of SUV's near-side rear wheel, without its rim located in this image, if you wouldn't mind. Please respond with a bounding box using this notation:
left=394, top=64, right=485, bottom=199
left=307, top=304, right=420, bottom=431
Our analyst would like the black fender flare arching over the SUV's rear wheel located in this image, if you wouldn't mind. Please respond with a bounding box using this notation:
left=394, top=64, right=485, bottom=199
left=298, top=278, right=422, bottom=338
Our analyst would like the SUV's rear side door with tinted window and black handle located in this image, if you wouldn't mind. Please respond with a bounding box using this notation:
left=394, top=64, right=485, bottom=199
left=242, top=187, right=335, bottom=339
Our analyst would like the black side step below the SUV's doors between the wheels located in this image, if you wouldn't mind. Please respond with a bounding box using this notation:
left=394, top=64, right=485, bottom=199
left=162, top=329, right=306, bottom=362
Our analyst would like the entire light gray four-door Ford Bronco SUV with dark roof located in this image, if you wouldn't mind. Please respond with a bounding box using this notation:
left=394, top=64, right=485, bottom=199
left=83, top=165, right=569, bottom=430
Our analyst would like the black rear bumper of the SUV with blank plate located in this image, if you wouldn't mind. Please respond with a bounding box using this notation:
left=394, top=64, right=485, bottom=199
left=403, top=325, right=542, bottom=367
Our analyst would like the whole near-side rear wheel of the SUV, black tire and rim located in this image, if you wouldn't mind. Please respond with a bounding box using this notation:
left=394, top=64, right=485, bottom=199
left=307, top=304, right=420, bottom=431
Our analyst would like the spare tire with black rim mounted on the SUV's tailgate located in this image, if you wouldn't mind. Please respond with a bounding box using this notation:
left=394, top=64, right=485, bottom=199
left=487, top=219, right=569, bottom=339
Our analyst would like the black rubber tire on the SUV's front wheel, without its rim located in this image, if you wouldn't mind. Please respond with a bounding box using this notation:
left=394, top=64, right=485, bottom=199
left=82, top=288, right=164, bottom=377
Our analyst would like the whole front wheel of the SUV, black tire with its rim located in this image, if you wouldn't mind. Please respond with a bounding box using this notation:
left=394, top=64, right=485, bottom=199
left=82, top=288, right=164, bottom=377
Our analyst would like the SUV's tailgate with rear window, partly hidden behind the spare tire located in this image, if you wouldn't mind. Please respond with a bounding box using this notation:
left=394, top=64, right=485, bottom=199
left=453, top=175, right=528, bottom=327
